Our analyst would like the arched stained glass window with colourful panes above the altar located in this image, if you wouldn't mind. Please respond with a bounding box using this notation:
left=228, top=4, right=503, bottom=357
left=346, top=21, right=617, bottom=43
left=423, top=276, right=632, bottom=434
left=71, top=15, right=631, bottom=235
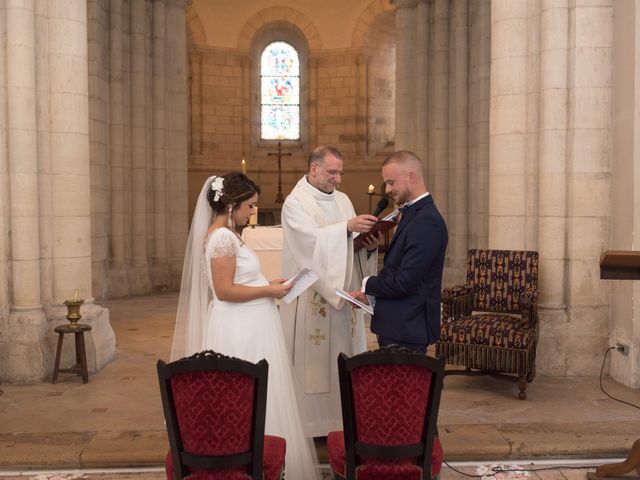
left=260, top=42, right=300, bottom=140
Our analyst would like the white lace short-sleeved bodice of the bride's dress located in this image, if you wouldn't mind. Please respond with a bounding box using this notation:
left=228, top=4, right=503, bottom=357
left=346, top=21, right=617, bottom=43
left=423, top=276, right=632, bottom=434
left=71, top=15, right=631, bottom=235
left=205, top=228, right=269, bottom=296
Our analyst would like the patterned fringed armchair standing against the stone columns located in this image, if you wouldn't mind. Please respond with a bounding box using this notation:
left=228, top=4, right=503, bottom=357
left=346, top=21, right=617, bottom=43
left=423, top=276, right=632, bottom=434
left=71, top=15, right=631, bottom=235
left=436, top=250, right=538, bottom=400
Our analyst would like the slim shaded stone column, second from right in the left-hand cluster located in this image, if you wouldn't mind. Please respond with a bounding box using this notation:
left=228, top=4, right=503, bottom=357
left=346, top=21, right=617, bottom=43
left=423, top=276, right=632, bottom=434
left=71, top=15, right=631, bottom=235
left=151, top=1, right=170, bottom=289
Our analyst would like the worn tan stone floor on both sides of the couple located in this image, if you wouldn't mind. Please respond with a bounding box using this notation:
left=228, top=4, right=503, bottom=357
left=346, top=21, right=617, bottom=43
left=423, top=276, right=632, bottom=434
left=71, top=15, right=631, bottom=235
left=0, top=294, right=640, bottom=480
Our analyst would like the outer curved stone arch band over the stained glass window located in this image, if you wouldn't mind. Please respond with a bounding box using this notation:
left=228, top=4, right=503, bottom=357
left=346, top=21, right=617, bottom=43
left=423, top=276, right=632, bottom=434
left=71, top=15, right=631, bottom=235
left=238, top=7, right=322, bottom=50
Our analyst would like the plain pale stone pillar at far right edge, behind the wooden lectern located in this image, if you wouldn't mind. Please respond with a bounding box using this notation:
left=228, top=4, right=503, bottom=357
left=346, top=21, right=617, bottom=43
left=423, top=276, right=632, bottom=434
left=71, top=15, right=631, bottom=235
left=603, top=2, right=640, bottom=388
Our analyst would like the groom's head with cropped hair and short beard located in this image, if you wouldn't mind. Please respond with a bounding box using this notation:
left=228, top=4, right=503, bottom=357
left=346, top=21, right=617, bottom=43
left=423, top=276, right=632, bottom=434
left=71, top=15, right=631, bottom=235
left=382, top=150, right=427, bottom=205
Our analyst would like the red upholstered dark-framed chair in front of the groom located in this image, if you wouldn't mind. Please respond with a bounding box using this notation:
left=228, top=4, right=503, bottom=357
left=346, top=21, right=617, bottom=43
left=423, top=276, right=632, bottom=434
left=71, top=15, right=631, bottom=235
left=327, top=346, right=444, bottom=480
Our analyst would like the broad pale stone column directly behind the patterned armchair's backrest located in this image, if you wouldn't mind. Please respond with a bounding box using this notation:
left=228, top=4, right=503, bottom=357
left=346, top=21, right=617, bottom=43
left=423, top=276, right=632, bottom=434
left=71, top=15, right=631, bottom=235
left=489, top=2, right=528, bottom=249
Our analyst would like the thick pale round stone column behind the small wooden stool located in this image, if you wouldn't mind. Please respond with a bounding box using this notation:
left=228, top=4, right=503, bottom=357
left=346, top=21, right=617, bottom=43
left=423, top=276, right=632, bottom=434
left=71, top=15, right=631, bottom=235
left=48, top=0, right=115, bottom=372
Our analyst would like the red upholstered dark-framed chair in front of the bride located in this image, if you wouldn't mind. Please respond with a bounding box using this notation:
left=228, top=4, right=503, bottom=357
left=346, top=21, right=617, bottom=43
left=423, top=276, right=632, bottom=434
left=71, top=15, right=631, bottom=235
left=157, top=350, right=286, bottom=480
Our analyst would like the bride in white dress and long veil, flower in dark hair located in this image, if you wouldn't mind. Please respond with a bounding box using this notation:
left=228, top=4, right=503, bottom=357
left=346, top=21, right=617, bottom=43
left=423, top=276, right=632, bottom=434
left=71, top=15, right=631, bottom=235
left=171, top=172, right=318, bottom=480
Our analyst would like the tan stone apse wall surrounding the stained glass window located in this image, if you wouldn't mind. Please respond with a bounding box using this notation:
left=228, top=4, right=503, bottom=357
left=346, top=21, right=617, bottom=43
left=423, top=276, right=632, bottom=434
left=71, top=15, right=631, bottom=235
left=187, top=0, right=395, bottom=212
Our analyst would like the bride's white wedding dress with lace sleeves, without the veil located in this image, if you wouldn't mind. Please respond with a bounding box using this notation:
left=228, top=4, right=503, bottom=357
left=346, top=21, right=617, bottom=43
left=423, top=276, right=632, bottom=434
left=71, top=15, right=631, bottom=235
left=203, top=228, right=318, bottom=480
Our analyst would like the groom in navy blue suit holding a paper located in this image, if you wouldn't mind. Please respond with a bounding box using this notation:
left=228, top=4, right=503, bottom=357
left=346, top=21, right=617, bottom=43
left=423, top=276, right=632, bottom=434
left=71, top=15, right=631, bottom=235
left=352, top=150, right=448, bottom=353
